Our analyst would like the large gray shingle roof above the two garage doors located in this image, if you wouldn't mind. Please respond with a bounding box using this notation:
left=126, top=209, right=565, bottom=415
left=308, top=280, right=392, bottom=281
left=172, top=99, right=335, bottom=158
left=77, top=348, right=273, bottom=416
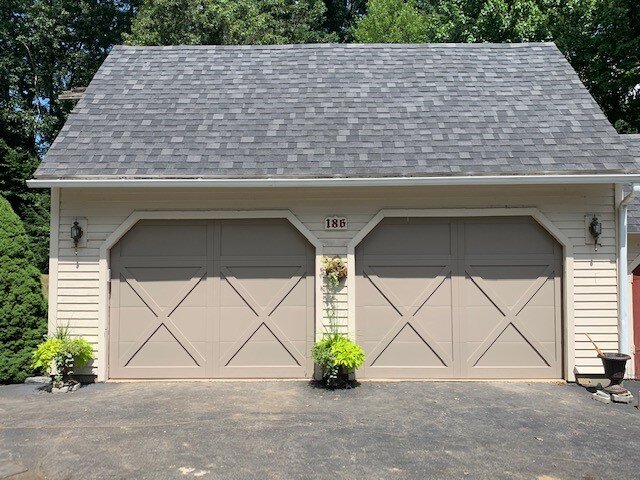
left=35, top=43, right=637, bottom=178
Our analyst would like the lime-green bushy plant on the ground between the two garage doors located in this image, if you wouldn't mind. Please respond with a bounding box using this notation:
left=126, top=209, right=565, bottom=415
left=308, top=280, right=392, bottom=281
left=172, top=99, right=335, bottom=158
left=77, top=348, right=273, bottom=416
left=311, top=333, right=365, bottom=382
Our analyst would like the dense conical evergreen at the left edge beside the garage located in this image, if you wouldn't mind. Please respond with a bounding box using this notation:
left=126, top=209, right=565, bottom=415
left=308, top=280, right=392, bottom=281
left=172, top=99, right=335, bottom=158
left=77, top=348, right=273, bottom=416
left=0, top=197, right=46, bottom=383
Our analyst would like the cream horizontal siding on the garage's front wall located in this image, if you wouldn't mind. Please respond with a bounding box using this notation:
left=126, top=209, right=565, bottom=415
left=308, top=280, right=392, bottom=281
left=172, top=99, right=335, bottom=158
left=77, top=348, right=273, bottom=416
left=54, top=185, right=620, bottom=373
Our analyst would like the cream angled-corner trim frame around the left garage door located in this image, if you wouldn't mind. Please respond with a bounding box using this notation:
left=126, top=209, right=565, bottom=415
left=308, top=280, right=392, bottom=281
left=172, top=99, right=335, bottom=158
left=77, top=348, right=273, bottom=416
left=97, top=210, right=324, bottom=381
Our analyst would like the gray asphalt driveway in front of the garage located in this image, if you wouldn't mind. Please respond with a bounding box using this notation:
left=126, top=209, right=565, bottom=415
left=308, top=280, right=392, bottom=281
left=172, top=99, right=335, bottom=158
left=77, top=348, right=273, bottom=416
left=0, top=381, right=640, bottom=480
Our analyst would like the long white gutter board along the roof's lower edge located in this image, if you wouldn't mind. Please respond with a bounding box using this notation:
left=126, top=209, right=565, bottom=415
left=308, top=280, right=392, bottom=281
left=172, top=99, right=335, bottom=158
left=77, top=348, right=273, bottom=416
left=27, top=174, right=640, bottom=188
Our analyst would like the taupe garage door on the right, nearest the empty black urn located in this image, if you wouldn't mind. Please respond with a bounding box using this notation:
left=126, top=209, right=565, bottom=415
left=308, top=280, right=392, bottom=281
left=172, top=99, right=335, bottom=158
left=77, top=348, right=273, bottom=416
left=356, top=218, right=562, bottom=378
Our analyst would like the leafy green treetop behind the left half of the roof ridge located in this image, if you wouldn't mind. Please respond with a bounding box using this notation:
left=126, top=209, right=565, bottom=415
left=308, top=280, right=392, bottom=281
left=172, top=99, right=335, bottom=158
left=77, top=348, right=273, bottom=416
left=124, top=0, right=338, bottom=45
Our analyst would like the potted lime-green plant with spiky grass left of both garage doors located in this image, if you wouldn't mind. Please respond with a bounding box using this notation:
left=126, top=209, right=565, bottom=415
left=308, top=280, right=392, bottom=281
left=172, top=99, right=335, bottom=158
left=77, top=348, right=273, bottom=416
left=32, top=327, right=93, bottom=393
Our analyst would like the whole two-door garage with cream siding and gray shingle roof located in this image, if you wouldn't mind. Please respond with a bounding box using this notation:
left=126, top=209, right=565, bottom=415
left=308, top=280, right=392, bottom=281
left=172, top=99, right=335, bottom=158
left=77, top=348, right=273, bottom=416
left=30, top=44, right=640, bottom=381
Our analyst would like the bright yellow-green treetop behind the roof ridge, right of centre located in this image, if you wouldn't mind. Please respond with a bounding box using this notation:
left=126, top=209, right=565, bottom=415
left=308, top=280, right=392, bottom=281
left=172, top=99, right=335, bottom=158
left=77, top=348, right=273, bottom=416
left=353, top=0, right=427, bottom=43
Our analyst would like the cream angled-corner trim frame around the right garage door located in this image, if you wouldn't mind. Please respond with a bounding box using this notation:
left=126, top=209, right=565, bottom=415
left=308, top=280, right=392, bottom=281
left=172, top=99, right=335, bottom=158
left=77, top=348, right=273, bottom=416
left=347, top=208, right=575, bottom=381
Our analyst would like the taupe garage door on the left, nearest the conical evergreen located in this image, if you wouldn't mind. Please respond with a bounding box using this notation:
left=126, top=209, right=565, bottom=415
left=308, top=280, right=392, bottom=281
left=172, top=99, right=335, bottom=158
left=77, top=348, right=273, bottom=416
left=109, top=220, right=314, bottom=378
